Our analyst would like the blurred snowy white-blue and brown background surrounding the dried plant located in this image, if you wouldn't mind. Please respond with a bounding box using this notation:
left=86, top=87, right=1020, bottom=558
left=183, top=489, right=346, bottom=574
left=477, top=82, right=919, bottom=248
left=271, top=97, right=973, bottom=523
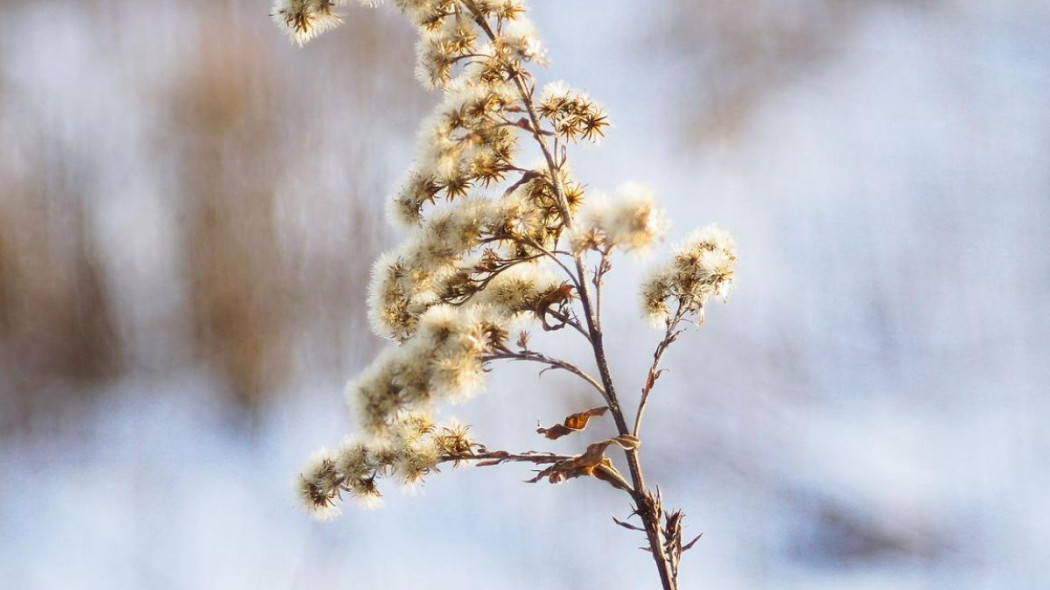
left=0, top=0, right=1050, bottom=590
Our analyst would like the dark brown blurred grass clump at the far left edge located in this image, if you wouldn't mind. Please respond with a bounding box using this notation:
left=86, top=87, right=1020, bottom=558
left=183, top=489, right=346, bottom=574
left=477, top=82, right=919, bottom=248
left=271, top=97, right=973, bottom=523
left=0, top=153, right=121, bottom=418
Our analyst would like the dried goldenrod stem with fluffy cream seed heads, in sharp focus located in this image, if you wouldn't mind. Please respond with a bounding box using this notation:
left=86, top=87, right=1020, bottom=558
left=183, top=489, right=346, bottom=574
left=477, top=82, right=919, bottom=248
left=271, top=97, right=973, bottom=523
left=271, top=0, right=736, bottom=590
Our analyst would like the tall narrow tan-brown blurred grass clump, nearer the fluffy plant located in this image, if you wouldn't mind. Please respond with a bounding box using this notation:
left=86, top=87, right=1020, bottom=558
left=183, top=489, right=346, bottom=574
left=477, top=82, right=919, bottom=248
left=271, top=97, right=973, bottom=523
left=170, top=38, right=301, bottom=402
